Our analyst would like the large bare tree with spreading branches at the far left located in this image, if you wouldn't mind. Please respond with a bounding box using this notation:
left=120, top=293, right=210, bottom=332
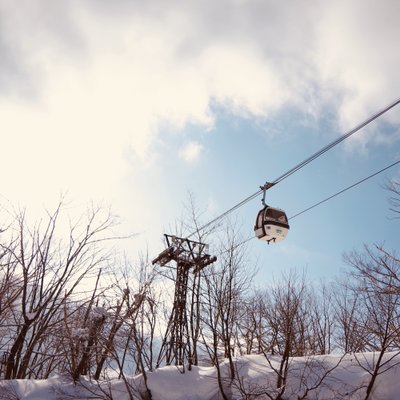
left=0, top=202, right=119, bottom=379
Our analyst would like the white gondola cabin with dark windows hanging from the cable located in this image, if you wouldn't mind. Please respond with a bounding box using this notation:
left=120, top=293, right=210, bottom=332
left=254, top=206, right=289, bottom=243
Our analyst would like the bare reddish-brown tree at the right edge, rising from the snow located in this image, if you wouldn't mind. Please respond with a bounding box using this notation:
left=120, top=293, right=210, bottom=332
left=345, top=246, right=400, bottom=400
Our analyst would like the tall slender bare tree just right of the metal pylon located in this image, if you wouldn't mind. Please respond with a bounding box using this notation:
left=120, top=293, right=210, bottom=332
left=201, top=225, right=255, bottom=399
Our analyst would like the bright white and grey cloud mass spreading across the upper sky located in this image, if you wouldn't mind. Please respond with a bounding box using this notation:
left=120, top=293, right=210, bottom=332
left=0, top=0, right=400, bottom=238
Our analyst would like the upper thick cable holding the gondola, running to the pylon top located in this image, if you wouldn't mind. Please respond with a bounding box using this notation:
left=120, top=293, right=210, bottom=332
left=188, top=98, right=400, bottom=238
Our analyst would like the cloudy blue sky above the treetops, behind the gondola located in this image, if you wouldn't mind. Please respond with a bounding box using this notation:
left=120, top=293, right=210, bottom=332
left=0, top=0, right=400, bottom=284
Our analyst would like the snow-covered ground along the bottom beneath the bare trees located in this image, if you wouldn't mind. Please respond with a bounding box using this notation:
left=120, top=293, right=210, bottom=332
left=0, top=353, right=400, bottom=400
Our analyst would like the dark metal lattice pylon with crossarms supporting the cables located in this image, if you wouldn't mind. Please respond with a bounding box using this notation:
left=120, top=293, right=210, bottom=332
left=153, top=235, right=217, bottom=367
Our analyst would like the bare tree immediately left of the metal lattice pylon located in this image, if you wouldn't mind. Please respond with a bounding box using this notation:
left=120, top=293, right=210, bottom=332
left=103, top=255, right=158, bottom=399
